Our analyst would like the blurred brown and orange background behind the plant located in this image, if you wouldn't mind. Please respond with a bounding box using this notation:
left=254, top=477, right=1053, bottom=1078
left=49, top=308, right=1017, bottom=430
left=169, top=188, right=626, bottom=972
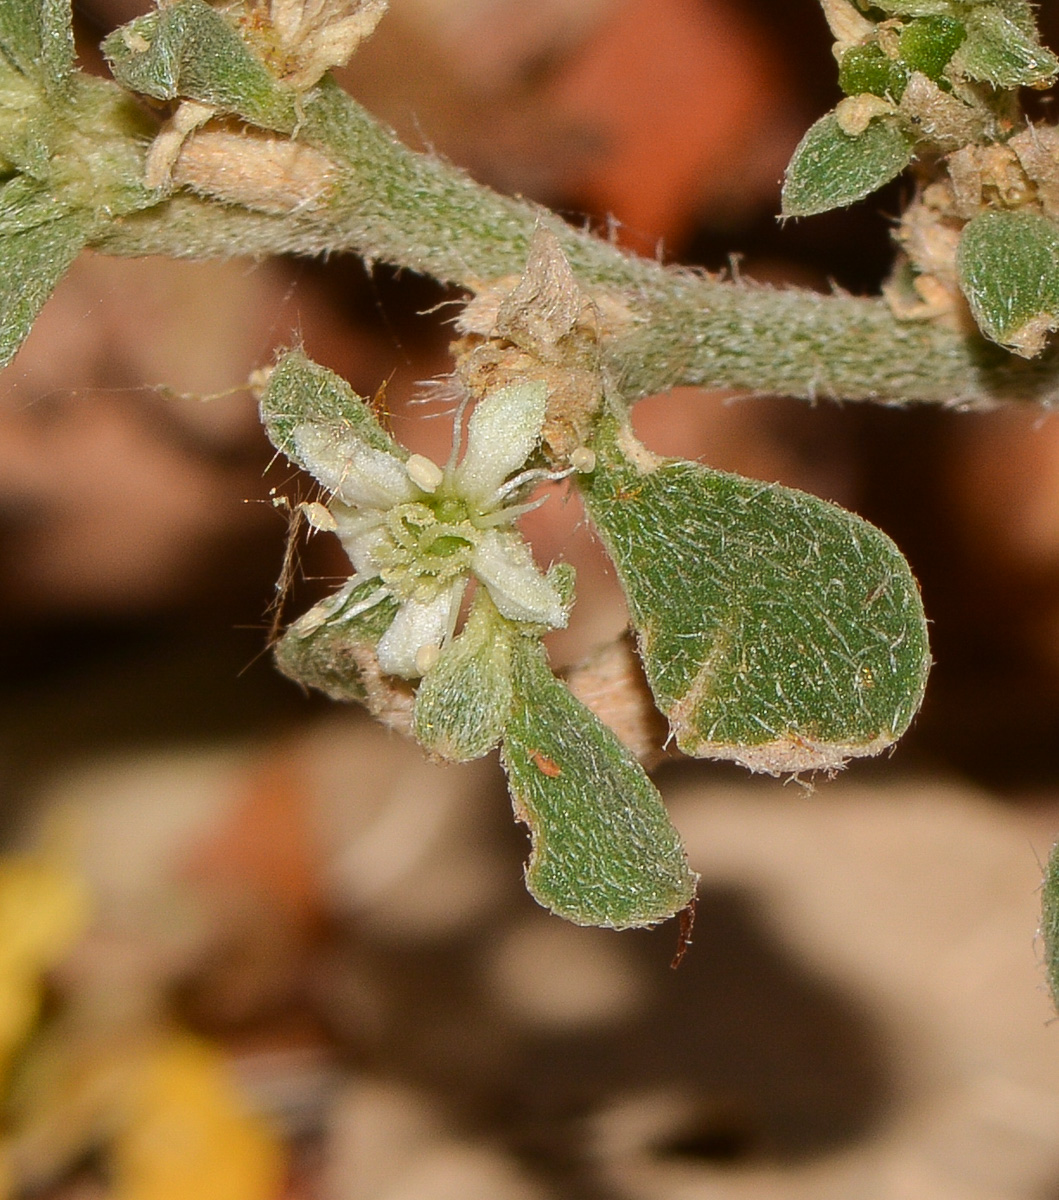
left=0, top=0, right=1059, bottom=1200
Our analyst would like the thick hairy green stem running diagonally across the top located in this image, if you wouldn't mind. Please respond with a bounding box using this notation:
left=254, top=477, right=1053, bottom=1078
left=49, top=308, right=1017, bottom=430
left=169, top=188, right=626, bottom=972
left=95, top=84, right=1059, bottom=407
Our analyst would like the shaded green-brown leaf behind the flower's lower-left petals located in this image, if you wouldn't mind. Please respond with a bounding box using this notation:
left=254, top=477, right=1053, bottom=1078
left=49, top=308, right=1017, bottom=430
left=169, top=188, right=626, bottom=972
left=274, top=580, right=397, bottom=707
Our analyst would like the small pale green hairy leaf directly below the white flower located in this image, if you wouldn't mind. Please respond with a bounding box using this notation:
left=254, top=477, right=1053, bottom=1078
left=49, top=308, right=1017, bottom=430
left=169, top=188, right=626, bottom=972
left=413, top=588, right=519, bottom=762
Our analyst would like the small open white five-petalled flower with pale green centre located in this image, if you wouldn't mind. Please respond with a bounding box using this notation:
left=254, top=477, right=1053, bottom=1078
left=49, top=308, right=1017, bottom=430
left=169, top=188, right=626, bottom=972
left=292, top=383, right=567, bottom=679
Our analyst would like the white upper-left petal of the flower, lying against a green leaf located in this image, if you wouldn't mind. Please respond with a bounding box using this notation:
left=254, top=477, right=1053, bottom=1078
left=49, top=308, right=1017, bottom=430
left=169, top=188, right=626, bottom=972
left=293, top=425, right=420, bottom=509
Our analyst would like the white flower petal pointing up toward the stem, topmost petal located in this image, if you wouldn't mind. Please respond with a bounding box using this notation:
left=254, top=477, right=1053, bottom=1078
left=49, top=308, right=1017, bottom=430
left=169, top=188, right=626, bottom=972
left=456, top=382, right=548, bottom=511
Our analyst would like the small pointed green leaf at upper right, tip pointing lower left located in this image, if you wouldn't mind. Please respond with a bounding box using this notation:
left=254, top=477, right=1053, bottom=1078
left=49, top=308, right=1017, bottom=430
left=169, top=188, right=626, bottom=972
left=783, top=113, right=915, bottom=217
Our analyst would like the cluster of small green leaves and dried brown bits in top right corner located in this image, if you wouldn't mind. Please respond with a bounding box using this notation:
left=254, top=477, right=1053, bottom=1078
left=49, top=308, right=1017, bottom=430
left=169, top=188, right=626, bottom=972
left=783, top=0, right=1059, bottom=358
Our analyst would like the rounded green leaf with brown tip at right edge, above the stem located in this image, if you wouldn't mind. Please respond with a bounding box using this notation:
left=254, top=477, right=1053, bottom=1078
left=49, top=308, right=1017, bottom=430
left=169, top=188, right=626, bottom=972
left=956, top=211, right=1059, bottom=358
